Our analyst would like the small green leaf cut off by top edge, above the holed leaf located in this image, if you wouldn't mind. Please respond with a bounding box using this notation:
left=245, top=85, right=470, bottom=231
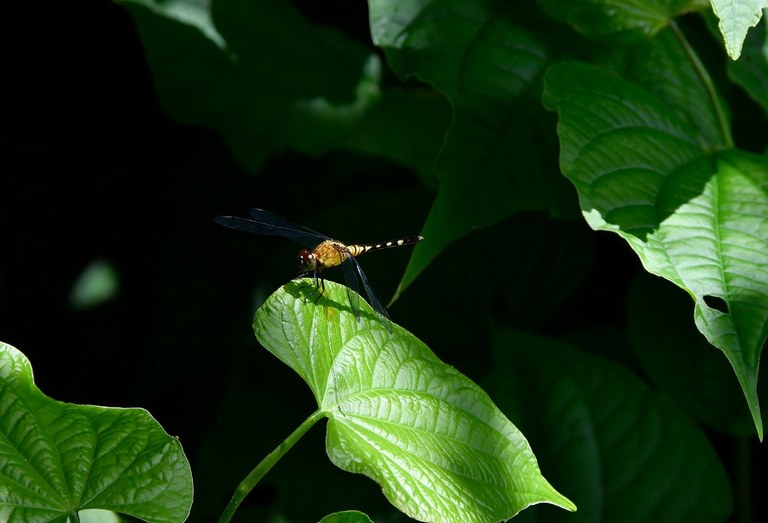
left=538, top=0, right=707, bottom=43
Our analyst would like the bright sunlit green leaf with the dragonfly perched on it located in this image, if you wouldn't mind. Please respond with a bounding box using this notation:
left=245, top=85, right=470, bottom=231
left=254, top=280, right=575, bottom=522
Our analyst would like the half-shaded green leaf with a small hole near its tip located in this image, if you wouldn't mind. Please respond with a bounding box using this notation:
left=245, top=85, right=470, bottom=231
left=545, top=63, right=768, bottom=437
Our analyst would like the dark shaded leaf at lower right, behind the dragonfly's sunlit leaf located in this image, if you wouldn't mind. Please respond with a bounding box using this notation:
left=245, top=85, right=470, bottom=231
left=488, top=330, right=733, bottom=523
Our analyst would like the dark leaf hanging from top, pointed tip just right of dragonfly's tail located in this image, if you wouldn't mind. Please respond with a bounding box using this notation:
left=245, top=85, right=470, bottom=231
left=369, top=0, right=572, bottom=302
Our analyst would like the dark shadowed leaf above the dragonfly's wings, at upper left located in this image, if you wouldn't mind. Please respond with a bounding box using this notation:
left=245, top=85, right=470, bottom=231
left=117, top=0, right=448, bottom=177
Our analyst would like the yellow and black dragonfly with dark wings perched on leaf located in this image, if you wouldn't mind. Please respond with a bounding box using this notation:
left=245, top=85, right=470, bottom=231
left=214, top=208, right=424, bottom=319
